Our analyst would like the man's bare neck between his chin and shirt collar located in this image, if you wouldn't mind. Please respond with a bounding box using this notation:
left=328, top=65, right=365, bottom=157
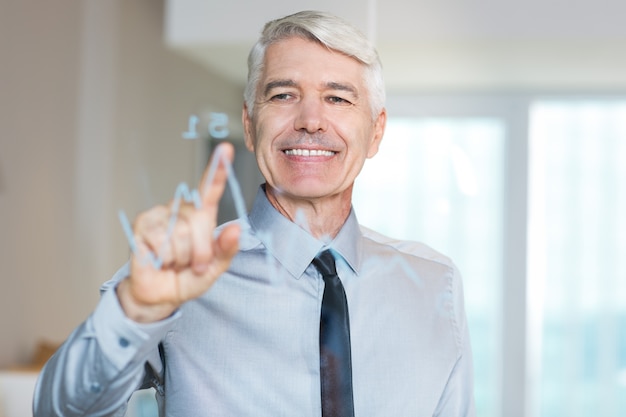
left=265, top=184, right=352, bottom=239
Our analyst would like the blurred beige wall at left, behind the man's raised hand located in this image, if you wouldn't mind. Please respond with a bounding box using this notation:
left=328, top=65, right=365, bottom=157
left=0, top=0, right=243, bottom=368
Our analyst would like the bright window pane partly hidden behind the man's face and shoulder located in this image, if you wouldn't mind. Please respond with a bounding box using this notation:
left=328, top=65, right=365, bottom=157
left=353, top=118, right=505, bottom=417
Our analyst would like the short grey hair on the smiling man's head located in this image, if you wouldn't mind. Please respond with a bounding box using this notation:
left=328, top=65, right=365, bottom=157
left=244, top=11, right=385, bottom=118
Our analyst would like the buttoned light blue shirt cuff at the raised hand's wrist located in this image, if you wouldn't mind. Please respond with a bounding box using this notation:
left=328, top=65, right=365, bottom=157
left=91, top=287, right=181, bottom=370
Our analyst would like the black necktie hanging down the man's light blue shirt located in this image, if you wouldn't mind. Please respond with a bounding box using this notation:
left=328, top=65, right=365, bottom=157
left=313, top=250, right=354, bottom=417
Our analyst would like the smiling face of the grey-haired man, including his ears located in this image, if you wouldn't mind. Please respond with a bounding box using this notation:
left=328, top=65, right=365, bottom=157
left=243, top=38, right=386, bottom=200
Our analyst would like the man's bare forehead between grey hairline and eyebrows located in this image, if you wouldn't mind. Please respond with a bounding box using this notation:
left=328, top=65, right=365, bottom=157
left=261, top=37, right=365, bottom=89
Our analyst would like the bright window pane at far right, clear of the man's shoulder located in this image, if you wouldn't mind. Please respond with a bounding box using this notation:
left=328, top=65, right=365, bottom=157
left=528, top=101, right=626, bottom=417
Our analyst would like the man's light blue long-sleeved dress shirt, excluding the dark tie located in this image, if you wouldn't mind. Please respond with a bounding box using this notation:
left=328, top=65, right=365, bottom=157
left=34, top=189, right=474, bottom=417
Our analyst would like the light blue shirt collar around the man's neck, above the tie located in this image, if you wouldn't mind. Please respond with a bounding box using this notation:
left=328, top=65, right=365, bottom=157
left=248, top=186, right=361, bottom=278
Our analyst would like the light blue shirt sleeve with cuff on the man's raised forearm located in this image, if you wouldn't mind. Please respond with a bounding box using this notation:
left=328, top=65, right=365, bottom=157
left=33, top=268, right=180, bottom=417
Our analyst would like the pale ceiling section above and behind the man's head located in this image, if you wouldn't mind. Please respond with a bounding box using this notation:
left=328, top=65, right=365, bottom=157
left=165, top=0, right=626, bottom=92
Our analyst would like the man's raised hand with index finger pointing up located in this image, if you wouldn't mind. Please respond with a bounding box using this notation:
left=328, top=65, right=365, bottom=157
left=117, top=143, right=240, bottom=322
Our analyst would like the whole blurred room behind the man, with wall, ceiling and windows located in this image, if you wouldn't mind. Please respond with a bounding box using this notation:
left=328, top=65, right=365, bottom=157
left=0, top=0, right=626, bottom=417
